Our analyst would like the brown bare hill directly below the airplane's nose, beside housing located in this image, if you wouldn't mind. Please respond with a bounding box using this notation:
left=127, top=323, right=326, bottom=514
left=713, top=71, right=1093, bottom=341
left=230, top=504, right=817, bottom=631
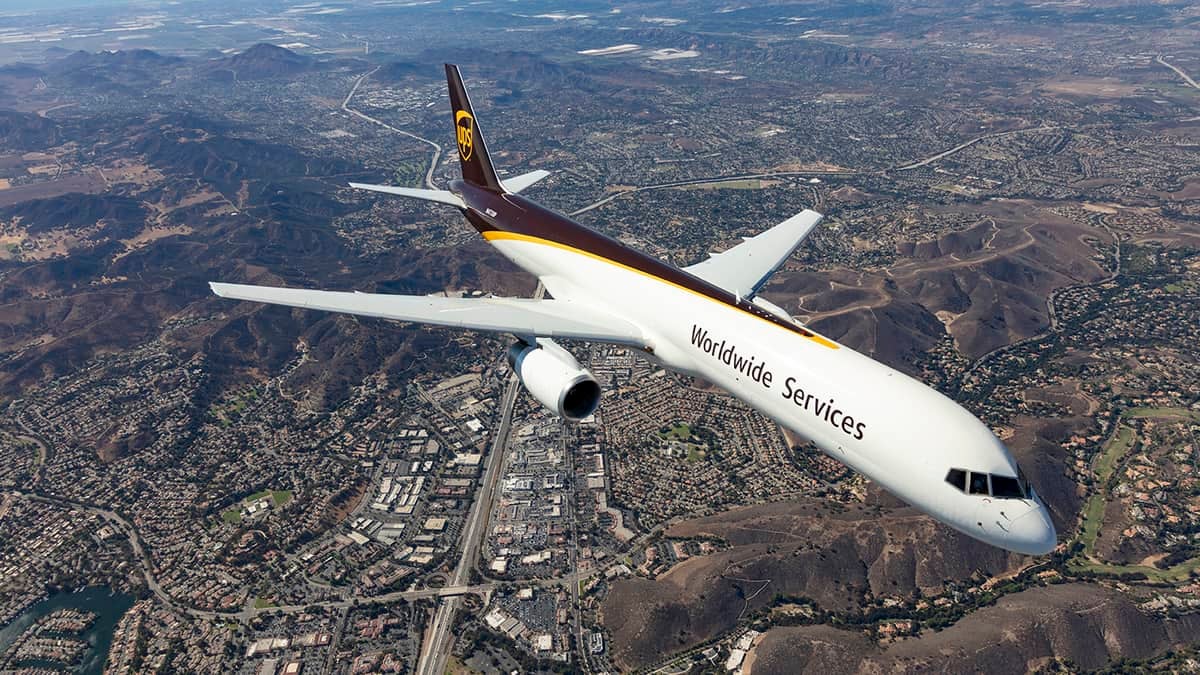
left=601, top=500, right=1020, bottom=668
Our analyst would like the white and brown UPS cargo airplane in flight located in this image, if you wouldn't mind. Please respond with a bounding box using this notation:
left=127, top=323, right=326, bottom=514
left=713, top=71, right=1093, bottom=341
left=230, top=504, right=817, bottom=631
left=211, top=64, right=1056, bottom=555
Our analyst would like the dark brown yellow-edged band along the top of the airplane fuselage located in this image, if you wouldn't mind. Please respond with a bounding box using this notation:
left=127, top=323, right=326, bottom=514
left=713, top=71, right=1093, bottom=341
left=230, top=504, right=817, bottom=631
left=451, top=180, right=838, bottom=350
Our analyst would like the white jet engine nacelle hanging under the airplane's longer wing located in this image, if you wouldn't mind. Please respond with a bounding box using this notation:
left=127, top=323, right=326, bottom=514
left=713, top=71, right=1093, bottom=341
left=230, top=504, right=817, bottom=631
left=509, top=342, right=600, bottom=422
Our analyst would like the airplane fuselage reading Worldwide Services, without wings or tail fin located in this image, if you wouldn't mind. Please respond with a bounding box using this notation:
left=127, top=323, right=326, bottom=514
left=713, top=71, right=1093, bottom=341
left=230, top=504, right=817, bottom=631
left=451, top=181, right=1055, bottom=555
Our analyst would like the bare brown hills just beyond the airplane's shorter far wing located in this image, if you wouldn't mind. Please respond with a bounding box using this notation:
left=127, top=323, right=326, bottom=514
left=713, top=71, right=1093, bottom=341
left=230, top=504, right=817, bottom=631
left=766, top=201, right=1109, bottom=368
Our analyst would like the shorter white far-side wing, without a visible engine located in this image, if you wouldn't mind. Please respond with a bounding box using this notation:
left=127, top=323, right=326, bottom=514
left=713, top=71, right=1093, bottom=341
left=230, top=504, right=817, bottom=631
left=684, top=209, right=823, bottom=298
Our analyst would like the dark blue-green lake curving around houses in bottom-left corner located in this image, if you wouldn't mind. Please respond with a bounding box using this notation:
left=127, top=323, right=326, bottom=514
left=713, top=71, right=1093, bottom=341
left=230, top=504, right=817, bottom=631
left=0, top=586, right=133, bottom=675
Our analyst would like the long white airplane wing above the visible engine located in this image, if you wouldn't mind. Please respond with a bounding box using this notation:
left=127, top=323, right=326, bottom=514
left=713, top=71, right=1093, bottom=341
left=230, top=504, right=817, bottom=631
left=209, top=281, right=648, bottom=347
